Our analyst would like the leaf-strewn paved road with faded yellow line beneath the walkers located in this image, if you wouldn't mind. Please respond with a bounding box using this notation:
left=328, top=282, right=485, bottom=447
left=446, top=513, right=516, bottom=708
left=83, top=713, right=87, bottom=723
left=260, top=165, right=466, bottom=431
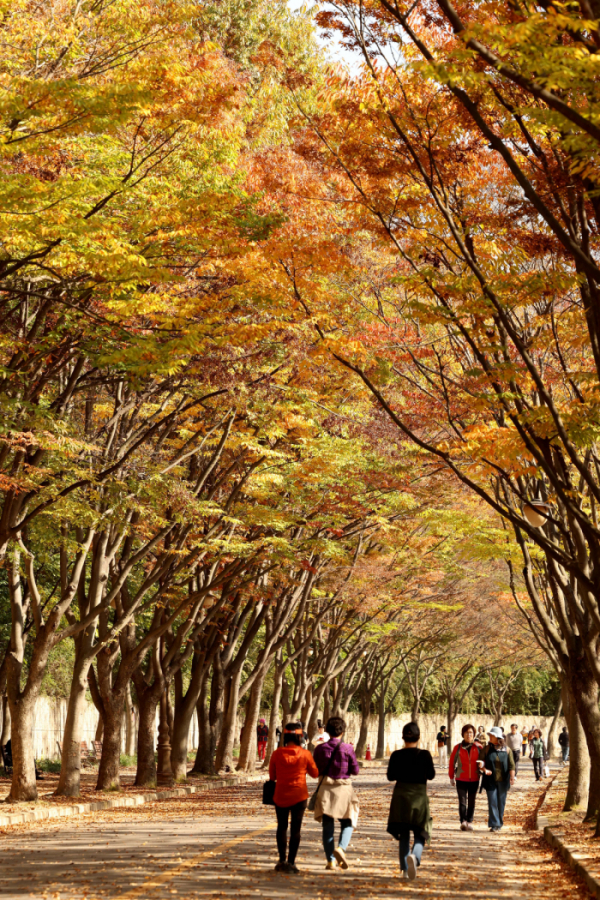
left=0, top=764, right=588, bottom=900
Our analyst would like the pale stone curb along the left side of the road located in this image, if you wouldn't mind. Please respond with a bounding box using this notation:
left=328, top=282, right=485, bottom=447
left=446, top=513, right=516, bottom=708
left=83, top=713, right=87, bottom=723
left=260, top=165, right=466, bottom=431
left=0, top=775, right=265, bottom=827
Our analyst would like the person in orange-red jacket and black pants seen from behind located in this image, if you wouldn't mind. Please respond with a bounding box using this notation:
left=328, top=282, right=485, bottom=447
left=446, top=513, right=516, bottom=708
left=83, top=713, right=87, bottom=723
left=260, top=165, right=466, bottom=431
left=269, top=722, right=319, bottom=875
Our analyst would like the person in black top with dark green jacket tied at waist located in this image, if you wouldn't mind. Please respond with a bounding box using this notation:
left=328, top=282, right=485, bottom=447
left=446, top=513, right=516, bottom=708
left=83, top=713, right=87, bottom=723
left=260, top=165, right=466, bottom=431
left=387, top=722, right=435, bottom=881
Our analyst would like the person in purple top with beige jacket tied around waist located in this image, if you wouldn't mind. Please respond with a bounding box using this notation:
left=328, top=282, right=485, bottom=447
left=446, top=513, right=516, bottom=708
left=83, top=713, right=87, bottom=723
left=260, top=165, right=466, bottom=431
left=315, top=716, right=360, bottom=869
